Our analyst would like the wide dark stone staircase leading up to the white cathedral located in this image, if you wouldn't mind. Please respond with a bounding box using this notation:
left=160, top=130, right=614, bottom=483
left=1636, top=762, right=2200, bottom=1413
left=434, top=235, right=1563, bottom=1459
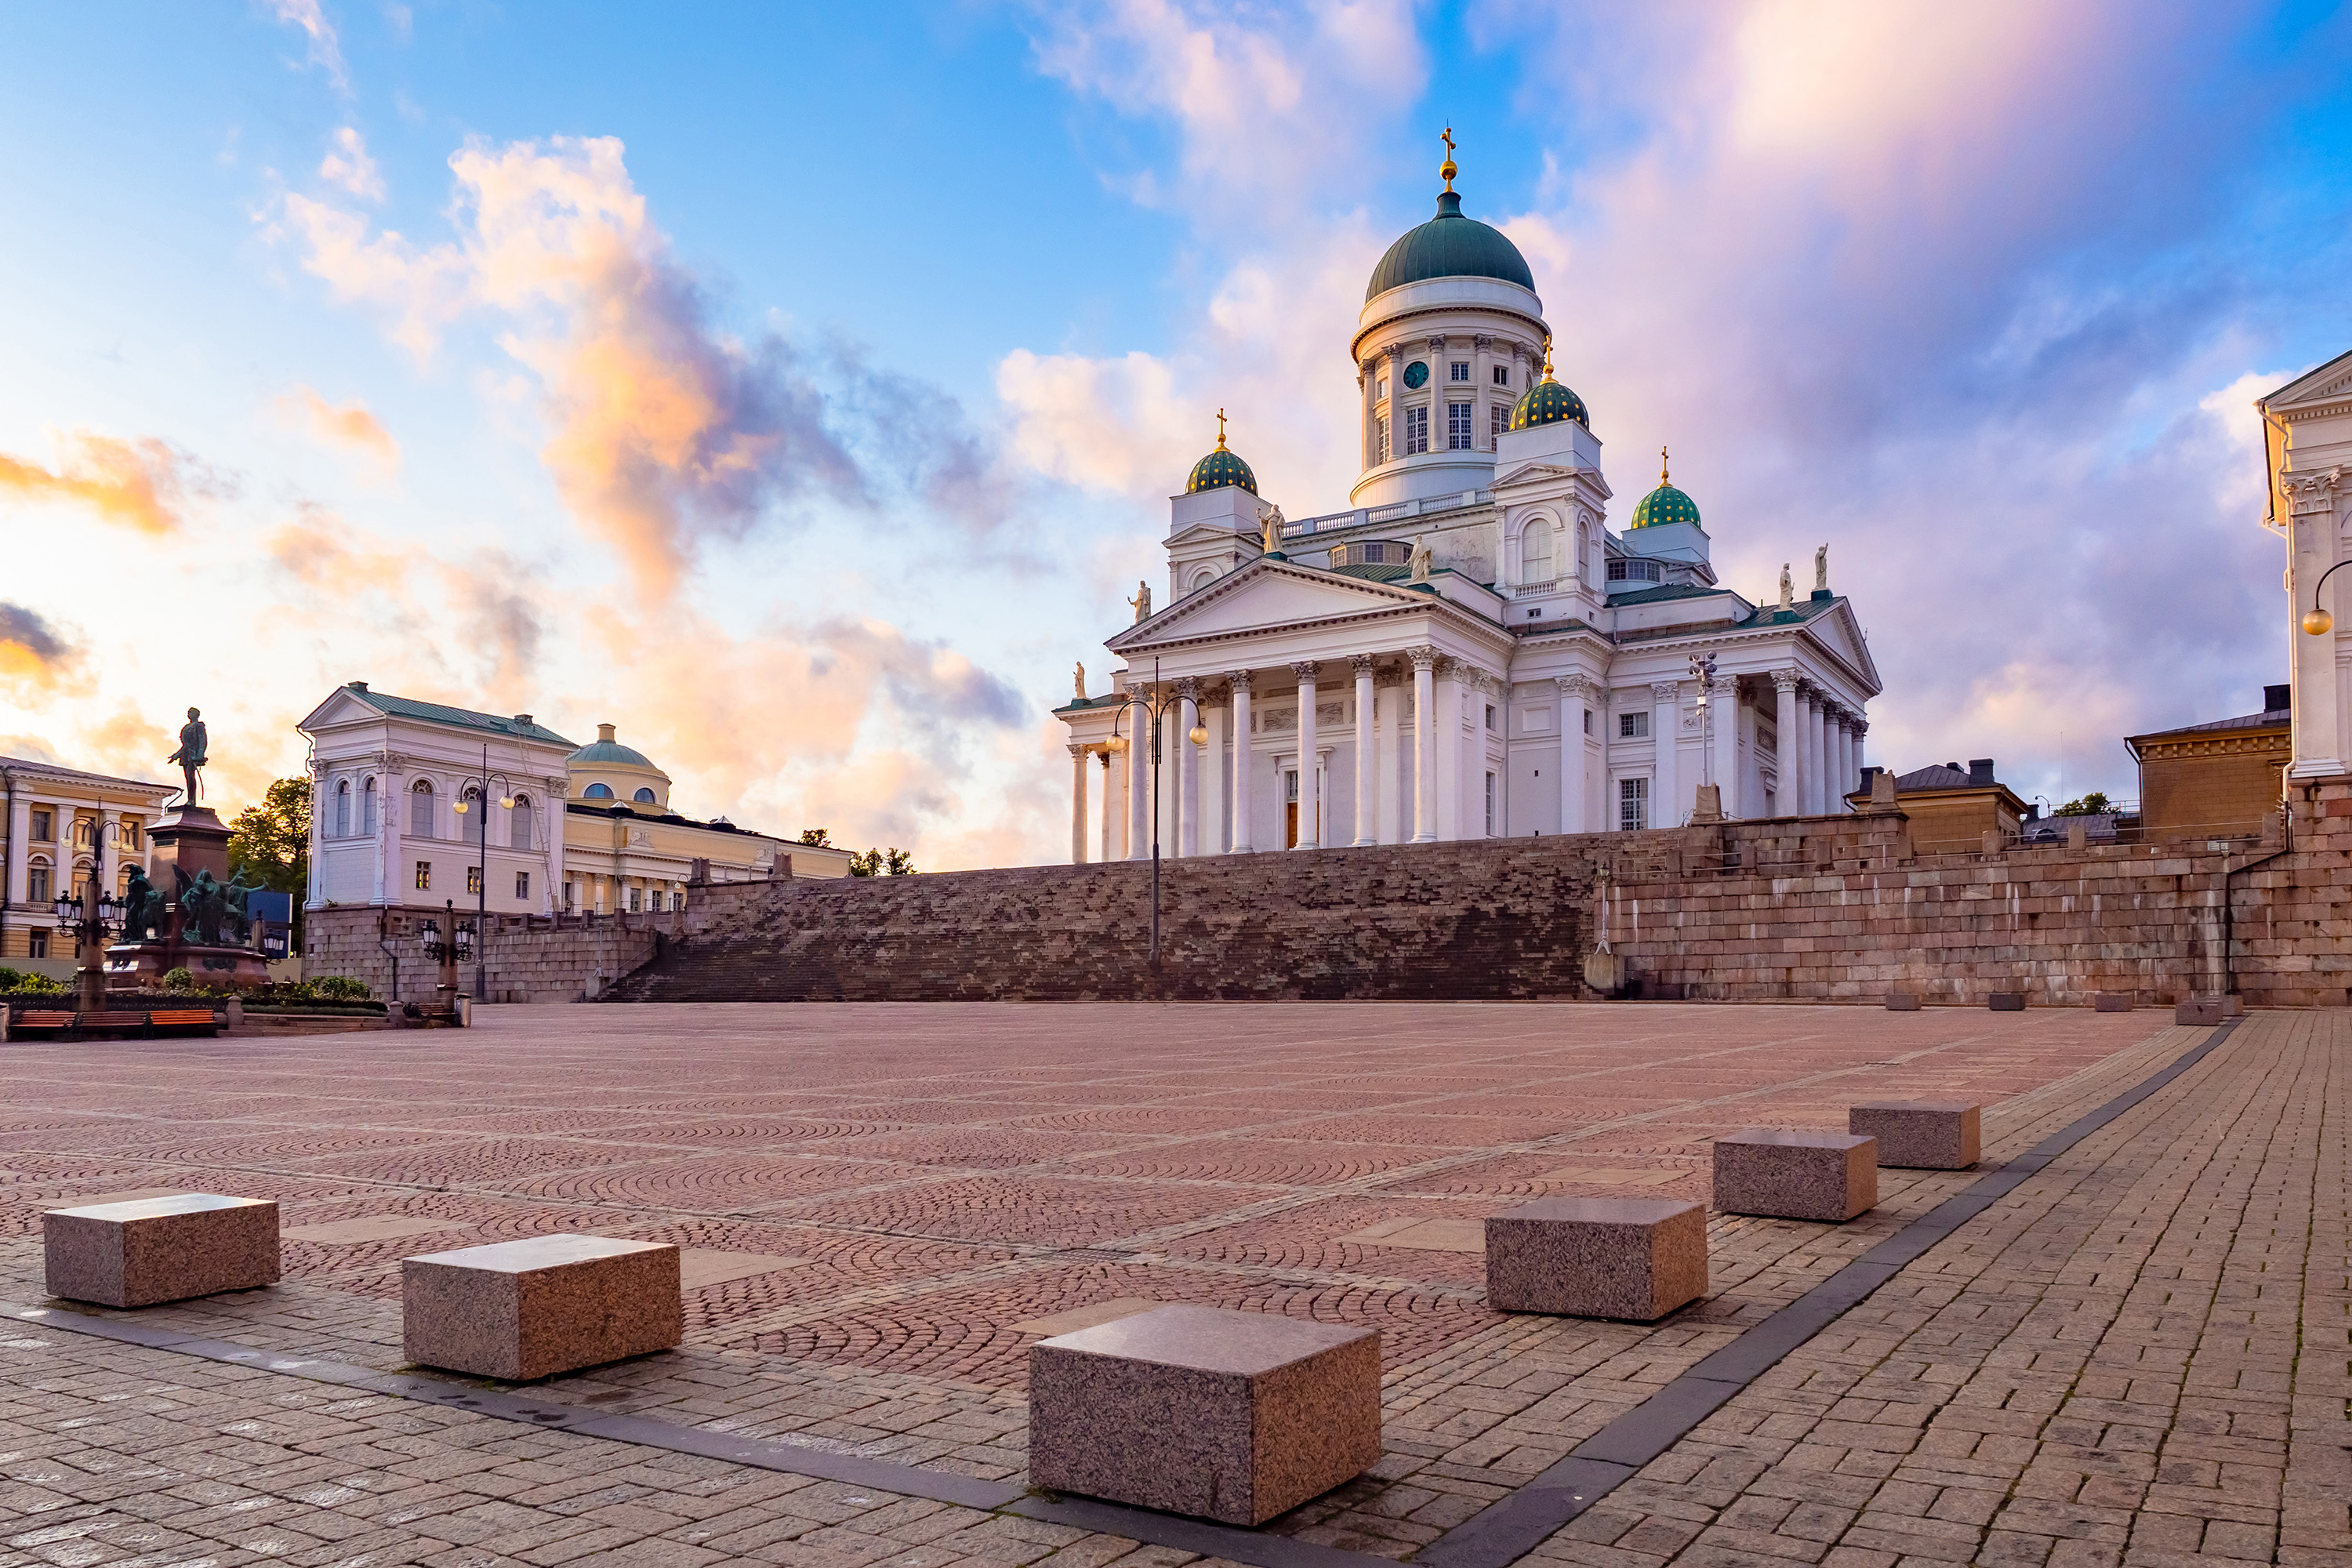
left=607, top=834, right=1637, bottom=1001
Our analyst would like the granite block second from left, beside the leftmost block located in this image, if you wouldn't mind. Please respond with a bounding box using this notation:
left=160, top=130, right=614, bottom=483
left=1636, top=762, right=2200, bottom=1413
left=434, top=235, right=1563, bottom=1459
left=400, top=1234, right=687, bottom=1382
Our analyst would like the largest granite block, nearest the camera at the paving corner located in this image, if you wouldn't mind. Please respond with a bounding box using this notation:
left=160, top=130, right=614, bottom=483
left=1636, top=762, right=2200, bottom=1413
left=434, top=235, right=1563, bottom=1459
left=1030, top=1307, right=1381, bottom=1526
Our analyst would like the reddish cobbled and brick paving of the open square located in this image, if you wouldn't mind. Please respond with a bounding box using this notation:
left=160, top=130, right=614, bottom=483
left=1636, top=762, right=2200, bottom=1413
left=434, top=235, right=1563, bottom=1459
left=0, top=1006, right=2352, bottom=1568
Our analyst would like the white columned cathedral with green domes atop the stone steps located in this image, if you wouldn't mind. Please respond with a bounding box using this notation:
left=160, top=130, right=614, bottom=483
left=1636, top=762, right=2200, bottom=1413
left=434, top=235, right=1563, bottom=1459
left=1056, top=158, right=1879, bottom=860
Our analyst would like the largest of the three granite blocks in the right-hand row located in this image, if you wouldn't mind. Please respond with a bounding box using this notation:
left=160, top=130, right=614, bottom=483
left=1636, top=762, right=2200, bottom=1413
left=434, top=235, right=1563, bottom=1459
left=1486, top=1199, right=1708, bottom=1323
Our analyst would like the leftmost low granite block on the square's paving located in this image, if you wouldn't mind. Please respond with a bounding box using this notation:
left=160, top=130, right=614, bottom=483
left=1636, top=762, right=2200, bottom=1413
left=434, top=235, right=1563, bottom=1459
left=40, top=1192, right=278, bottom=1307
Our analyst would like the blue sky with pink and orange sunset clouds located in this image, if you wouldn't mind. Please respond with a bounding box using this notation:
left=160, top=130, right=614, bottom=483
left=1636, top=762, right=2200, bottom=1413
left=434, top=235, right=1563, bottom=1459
left=0, top=0, right=2352, bottom=867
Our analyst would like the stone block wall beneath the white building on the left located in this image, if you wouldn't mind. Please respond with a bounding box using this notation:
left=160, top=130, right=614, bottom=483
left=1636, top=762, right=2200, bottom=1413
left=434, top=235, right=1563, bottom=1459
left=303, top=907, right=677, bottom=1001
